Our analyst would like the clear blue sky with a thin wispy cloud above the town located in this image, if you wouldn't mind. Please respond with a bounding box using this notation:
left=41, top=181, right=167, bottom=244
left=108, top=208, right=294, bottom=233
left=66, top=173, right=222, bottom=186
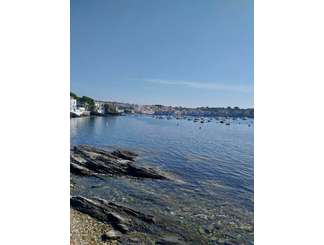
left=71, top=0, right=253, bottom=108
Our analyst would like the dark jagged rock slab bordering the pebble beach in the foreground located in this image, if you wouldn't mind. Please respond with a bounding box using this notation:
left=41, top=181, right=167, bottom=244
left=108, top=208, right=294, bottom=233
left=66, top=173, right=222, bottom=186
left=70, top=196, right=155, bottom=233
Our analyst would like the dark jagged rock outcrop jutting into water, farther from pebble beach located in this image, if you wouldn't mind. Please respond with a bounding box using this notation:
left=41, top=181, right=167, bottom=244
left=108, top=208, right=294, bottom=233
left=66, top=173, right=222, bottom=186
left=70, top=145, right=167, bottom=179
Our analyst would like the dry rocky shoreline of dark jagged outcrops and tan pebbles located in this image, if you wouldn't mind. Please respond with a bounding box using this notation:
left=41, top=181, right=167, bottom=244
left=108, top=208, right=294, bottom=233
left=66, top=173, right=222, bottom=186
left=70, top=145, right=190, bottom=245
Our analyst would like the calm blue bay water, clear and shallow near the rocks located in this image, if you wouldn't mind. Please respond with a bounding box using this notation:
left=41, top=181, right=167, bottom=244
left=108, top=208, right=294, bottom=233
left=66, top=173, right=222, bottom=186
left=70, top=115, right=254, bottom=244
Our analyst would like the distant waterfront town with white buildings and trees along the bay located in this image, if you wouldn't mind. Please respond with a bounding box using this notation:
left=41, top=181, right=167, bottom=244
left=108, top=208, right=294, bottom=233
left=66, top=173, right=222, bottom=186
left=70, top=92, right=254, bottom=120
